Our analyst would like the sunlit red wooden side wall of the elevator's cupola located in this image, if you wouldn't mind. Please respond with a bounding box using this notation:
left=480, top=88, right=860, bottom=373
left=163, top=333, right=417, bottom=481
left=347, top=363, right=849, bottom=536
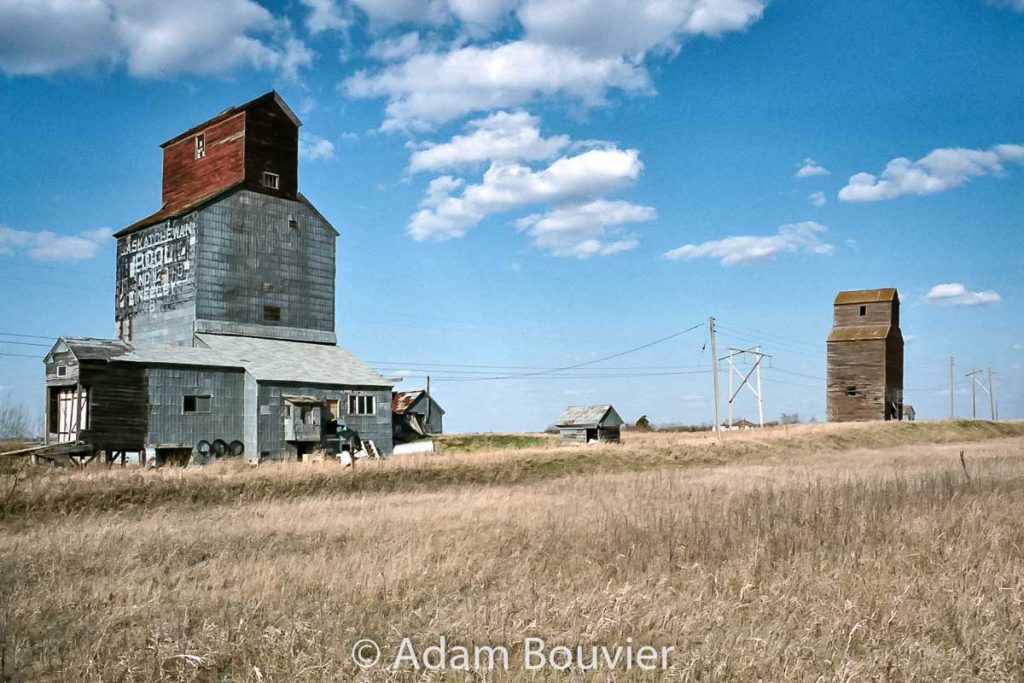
left=163, top=112, right=246, bottom=207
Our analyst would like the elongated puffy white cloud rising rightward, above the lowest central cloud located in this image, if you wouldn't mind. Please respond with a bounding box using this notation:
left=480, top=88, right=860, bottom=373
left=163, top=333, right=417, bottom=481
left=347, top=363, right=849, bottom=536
left=409, top=147, right=643, bottom=240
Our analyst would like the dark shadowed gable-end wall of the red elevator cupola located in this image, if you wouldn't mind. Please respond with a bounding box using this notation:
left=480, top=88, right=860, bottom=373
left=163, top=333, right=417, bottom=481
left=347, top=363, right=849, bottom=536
left=245, top=99, right=299, bottom=199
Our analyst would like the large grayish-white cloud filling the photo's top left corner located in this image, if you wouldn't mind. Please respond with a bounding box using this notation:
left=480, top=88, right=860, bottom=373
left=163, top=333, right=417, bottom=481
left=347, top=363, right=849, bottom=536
left=0, top=0, right=312, bottom=77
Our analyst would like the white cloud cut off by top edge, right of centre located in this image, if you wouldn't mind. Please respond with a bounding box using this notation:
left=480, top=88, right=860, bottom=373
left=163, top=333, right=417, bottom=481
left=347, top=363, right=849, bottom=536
left=517, top=0, right=766, bottom=56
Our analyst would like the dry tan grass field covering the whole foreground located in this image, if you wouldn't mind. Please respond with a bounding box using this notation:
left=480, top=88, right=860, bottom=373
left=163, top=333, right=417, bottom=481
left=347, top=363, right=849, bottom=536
left=0, top=422, right=1024, bottom=681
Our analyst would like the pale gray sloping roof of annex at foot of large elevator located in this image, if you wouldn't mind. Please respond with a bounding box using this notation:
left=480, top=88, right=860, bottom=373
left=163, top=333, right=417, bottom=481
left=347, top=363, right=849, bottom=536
left=196, top=334, right=394, bottom=387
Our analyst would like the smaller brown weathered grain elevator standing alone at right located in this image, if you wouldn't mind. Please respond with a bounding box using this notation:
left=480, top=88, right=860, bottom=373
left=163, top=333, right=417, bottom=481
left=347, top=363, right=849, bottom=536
left=827, top=288, right=903, bottom=422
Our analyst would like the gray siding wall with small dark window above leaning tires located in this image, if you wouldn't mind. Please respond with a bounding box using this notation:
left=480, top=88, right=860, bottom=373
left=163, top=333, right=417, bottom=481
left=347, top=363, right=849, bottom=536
left=146, top=367, right=249, bottom=454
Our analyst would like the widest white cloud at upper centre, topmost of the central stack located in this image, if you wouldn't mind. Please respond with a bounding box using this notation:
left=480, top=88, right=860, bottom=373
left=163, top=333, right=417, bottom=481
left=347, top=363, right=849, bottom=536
left=345, top=41, right=650, bottom=130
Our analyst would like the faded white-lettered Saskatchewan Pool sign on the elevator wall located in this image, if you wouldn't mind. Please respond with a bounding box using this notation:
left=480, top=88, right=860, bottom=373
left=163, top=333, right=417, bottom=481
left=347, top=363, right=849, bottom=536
left=115, top=215, right=197, bottom=322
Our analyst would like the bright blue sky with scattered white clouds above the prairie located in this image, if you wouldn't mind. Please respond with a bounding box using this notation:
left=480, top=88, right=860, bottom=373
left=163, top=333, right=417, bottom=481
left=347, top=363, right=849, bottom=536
left=0, top=0, right=1024, bottom=430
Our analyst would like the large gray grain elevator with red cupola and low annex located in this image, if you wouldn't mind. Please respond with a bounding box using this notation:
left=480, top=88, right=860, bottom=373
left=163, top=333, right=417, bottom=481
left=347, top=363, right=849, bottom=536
left=44, top=91, right=394, bottom=460
